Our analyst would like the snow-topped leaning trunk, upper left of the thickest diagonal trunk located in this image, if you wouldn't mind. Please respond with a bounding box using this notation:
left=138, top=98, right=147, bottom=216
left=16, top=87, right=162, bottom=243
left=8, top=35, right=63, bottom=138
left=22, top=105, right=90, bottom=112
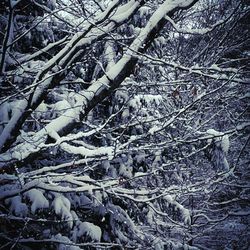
left=0, top=1, right=146, bottom=150
